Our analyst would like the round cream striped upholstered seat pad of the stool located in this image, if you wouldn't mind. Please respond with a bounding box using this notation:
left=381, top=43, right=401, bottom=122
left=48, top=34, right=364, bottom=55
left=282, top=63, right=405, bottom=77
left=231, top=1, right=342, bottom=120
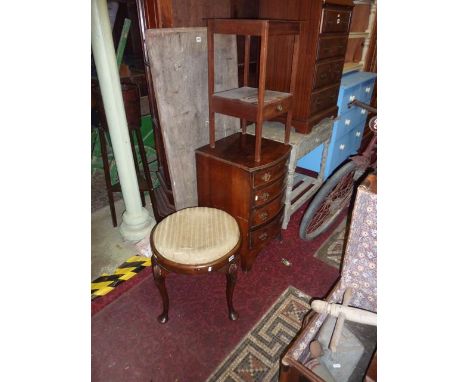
left=152, top=207, right=240, bottom=265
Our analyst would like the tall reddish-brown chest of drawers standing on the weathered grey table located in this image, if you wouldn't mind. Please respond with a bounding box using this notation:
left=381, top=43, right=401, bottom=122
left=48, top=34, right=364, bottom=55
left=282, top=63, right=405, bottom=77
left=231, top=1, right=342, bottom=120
left=259, top=0, right=353, bottom=134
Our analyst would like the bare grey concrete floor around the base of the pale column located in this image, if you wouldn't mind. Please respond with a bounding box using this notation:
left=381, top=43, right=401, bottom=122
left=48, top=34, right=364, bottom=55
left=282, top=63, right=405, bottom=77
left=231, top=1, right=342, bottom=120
left=91, top=191, right=153, bottom=281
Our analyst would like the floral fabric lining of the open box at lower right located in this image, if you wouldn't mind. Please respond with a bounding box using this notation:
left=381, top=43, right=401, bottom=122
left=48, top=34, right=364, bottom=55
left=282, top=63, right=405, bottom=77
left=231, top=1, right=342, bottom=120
left=288, top=179, right=377, bottom=362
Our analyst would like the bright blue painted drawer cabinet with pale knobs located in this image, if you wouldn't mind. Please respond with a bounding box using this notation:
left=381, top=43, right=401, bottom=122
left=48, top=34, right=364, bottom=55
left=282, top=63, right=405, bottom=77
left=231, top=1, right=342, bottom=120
left=297, top=72, right=377, bottom=179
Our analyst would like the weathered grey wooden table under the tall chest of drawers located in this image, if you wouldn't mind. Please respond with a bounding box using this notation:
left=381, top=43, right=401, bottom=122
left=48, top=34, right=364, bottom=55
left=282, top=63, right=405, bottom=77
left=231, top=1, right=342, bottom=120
left=247, top=118, right=333, bottom=229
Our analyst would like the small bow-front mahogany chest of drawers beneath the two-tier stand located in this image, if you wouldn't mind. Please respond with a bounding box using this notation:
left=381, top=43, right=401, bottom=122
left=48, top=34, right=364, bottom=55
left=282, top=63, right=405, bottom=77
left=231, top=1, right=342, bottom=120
left=195, top=133, right=291, bottom=271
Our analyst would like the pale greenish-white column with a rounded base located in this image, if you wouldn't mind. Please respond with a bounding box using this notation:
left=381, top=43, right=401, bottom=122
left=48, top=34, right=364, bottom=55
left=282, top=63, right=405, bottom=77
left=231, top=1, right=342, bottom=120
left=91, top=0, right=155, bottom=241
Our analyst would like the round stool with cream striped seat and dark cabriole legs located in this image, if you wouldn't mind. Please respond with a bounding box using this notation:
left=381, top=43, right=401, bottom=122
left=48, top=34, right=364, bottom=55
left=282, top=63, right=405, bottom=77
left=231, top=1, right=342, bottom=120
left=150, top=207, right=241, bottom=323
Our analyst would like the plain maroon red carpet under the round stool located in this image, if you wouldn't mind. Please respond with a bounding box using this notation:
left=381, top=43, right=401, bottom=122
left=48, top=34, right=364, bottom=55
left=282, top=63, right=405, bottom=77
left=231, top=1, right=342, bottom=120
left=91, top=207, right=346, bottom=382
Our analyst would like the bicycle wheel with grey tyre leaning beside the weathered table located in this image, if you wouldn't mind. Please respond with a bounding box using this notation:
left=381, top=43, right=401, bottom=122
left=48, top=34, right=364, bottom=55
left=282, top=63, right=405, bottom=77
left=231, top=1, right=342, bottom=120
left=299, top=161, right=364, bottom=240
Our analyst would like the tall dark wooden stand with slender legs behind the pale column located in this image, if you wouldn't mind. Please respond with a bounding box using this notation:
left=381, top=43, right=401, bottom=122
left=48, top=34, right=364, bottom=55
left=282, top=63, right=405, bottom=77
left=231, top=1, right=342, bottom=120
left=93, top=83, right=161, bottom=227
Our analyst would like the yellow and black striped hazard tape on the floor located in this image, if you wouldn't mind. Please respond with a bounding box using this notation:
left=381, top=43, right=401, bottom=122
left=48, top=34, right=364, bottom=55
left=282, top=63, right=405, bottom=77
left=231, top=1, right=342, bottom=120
left=91, top=256, right=151, bottom=300
